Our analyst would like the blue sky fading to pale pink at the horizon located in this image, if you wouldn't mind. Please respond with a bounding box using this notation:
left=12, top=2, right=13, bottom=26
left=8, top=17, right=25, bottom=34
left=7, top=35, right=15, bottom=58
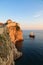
left=0, top=0, right=43, bottom=30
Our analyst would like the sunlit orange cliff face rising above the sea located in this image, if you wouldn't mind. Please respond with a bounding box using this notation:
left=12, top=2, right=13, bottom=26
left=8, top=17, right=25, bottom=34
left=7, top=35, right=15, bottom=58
left=6, top=20, right=23, bottom=43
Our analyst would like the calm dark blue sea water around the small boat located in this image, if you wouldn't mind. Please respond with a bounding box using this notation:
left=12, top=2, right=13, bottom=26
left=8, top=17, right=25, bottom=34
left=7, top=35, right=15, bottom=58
left=16, top=30, right=43, bottom=65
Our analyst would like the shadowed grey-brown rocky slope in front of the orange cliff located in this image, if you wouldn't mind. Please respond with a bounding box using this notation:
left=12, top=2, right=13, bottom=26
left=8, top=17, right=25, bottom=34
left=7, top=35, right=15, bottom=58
left=0, top=26, right=22, bottom=65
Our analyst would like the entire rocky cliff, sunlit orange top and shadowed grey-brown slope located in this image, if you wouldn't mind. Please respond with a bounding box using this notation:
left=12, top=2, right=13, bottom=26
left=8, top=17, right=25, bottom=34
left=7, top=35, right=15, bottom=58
left=0, top=20, right=23, bottom=65
